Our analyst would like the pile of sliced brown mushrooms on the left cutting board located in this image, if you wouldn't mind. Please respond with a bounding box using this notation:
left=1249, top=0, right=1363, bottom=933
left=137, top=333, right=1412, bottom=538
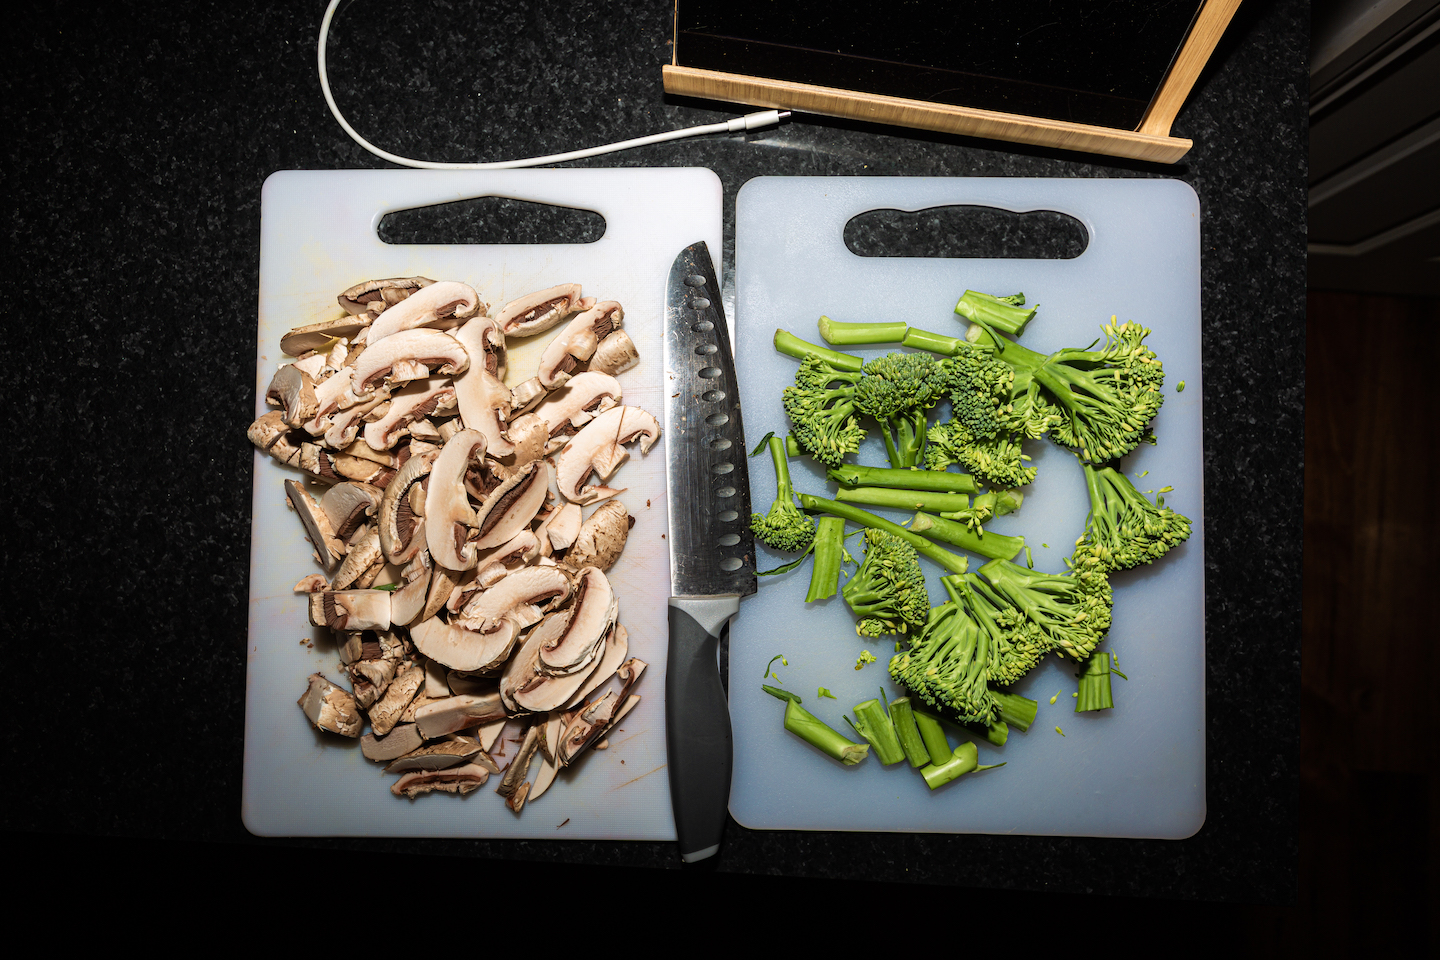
left=249, top=276, right=660, bottom=813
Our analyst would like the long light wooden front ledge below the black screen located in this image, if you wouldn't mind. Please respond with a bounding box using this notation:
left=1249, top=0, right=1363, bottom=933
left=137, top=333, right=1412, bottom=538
left=661, top=65, right=1192, bottom=163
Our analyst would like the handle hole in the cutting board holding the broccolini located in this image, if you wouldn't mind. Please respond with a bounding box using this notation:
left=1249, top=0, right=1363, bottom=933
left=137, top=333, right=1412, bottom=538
left=845, top=204, right=1090, bottom=261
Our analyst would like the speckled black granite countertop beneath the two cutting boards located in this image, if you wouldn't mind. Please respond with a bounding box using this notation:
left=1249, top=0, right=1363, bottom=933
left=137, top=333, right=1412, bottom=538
left=0, top=0, right=1308, bottom=902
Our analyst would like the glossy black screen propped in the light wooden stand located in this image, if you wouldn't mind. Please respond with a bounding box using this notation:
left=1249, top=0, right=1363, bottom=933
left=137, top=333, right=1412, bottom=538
left=675, top=0, right=1202, bottom=130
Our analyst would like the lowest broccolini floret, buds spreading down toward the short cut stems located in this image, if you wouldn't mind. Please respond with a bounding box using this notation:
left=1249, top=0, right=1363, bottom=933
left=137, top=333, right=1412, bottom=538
left=890, top=577, right=999, bottom=724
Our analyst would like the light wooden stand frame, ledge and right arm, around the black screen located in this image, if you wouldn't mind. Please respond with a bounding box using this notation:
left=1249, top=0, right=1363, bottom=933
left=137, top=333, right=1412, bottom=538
left=661, top=0, right=1240, bottom=163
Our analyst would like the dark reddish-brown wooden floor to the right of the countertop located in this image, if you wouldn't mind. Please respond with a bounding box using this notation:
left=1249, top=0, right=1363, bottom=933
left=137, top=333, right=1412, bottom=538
left=1284, top=291, right=1440, bottom=956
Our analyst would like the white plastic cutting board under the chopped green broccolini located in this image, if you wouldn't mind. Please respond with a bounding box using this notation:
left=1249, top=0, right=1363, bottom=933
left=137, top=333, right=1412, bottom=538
left=730, top=177, right=1205, bottom=838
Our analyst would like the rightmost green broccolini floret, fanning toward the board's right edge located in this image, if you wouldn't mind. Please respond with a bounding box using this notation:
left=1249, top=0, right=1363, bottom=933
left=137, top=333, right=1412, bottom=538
left=1074, top=463, right=1189, bottom=573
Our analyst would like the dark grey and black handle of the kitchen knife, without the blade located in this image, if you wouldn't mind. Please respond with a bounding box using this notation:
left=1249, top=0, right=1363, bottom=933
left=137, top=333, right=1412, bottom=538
left=665, top=603, right=733, bottom=864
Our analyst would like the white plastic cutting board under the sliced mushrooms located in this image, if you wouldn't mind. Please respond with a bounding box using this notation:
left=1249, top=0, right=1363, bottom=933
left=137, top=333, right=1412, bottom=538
left=242, top=168, right=721, bottom=841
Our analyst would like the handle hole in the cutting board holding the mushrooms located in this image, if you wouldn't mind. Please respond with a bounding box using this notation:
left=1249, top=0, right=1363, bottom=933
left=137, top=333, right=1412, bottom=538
left=376, top=197, right=605, bottom=243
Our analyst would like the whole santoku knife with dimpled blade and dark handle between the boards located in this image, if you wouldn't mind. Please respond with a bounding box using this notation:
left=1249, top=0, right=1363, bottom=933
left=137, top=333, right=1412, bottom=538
left=664, top=242, right=756, bottom=862
